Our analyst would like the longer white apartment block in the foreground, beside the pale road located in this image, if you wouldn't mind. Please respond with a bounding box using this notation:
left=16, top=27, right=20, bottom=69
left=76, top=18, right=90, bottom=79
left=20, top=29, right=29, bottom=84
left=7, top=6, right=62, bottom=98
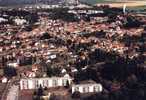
left=20, top=77, right=72, bottom=90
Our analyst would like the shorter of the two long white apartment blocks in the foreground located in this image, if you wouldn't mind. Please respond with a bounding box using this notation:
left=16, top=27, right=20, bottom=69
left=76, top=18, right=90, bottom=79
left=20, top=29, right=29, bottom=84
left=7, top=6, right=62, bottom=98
left=72, top=83, right=103, bottom=93
